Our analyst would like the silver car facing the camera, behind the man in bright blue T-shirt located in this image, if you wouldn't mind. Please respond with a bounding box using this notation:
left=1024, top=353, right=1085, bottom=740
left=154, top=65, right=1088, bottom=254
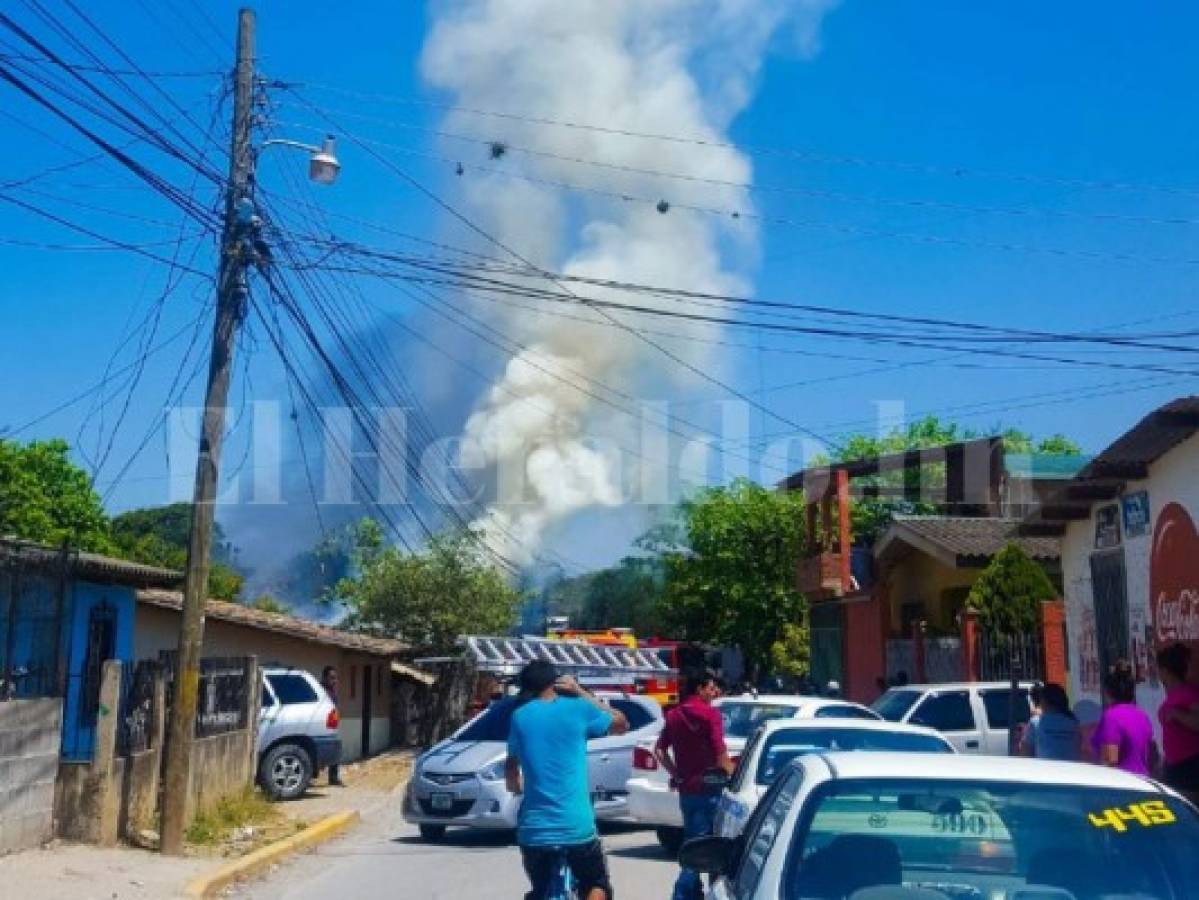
left=403, top=691, right=662, bottom=840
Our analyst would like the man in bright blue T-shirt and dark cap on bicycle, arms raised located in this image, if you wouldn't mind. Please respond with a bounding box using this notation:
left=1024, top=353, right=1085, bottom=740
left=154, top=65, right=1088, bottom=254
left=505, top=659, right=628, bottom=900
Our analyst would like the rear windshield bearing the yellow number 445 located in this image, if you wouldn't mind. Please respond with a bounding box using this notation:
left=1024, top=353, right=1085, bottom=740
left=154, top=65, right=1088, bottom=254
left=781, top=779, right=1199, bottom=900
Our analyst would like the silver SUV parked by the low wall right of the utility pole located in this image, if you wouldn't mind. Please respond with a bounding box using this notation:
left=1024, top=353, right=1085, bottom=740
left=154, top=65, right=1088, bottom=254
left=258, top=666, right=342, bottom=801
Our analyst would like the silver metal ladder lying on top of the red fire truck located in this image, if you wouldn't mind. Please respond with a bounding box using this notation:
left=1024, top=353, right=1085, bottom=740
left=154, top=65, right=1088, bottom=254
left=463, top=635, right=675, bottom=684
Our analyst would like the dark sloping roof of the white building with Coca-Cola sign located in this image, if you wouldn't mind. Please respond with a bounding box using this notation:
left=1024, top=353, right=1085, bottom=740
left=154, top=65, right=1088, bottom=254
left=1020, top=395, right=1199, bottom=533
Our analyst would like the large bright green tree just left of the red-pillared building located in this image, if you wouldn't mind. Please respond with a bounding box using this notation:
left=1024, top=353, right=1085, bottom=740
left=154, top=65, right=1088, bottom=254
left=661, top=481, right=807, bottom=674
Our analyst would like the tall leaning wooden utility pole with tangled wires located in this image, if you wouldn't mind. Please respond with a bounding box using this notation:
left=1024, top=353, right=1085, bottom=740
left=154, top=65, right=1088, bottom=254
left=161, top=10, right=257, bottom=856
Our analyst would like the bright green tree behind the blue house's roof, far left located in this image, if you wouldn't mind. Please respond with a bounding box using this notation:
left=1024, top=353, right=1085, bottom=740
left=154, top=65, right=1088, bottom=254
left=0, top=439, right=110, bottom=552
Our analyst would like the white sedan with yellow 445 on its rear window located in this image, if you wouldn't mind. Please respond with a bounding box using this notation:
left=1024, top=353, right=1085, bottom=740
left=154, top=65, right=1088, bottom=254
left=680, top=753, right=1199, bottom=900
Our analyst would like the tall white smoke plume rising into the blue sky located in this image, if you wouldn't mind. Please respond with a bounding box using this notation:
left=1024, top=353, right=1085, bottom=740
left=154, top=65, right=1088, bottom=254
left=422, top=0, right=837, bottom=562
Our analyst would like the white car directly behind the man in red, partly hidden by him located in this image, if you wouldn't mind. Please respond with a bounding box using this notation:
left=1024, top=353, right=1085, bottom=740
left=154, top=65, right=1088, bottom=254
left=626, top=694, right=882, bottom=856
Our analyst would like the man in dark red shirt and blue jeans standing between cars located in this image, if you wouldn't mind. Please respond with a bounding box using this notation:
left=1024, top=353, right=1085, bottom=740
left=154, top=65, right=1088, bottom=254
left=653, top=670, right=733, bottom=900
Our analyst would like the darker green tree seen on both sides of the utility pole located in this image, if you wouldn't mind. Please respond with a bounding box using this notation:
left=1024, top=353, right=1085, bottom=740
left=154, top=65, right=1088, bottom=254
left=110, top=503, right=245, bottom=602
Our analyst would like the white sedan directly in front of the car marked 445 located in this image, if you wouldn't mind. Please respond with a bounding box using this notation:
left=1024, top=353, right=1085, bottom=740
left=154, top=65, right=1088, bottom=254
left=716, top=719, right=956, bottom=838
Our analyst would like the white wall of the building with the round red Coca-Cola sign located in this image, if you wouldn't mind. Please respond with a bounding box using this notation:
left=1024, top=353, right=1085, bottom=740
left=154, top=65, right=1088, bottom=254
left=1062, top=434, right=1199, bottom=729
